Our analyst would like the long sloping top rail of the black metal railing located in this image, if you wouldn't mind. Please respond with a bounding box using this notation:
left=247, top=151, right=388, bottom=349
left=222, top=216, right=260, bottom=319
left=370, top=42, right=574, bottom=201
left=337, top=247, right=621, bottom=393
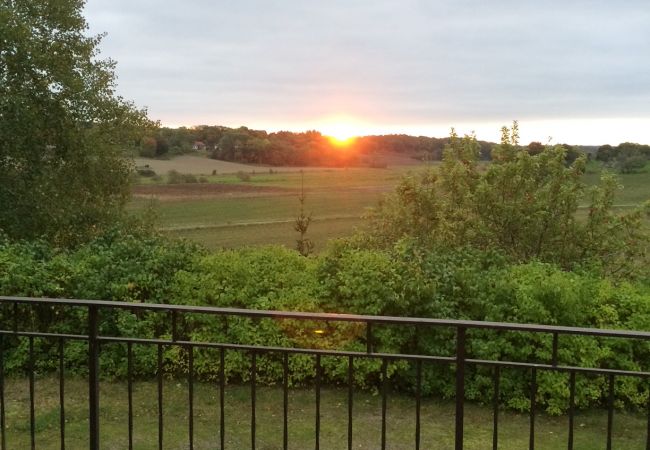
left=0, top=296, right=650, bottom=340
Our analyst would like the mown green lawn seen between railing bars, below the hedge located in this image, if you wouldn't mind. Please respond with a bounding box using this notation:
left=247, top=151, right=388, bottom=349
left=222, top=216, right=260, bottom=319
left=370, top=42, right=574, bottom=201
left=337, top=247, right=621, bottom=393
left=5, top=377, right=646, bottom=450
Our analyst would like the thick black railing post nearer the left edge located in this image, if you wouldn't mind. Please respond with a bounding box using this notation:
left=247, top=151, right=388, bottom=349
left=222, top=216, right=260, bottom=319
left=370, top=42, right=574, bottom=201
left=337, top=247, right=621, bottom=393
left=88, top=306, right=99, bottom=450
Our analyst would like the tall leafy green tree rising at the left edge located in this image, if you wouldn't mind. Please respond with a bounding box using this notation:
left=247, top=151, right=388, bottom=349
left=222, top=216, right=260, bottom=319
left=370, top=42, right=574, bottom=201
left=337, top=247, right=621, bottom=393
left=0, top=0, right=152, bottom=244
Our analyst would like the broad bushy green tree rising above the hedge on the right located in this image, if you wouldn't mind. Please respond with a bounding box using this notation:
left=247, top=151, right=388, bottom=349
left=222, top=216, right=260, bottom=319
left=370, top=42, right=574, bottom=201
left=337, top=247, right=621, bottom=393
left=355, top=122, right=650, bottom=278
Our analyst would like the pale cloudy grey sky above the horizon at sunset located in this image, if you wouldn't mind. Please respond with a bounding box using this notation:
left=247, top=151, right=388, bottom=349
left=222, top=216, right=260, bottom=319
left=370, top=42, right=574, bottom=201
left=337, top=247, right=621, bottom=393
left=85, top=0, right=650, bottom=145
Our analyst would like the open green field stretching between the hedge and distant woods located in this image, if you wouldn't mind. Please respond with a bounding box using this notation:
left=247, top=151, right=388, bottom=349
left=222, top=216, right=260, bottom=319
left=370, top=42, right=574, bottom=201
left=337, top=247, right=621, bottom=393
left=130, top=164, right=650, bottom=251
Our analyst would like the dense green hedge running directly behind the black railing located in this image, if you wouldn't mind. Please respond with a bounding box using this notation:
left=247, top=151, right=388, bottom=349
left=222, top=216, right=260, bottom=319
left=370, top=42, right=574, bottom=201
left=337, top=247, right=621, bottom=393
left=0, top=236, right=650, bottom=413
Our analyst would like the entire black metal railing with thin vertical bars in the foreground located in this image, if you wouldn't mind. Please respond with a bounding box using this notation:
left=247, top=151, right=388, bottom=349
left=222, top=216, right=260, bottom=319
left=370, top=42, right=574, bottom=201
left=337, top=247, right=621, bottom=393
left=0, top=297, right=650, bottom=450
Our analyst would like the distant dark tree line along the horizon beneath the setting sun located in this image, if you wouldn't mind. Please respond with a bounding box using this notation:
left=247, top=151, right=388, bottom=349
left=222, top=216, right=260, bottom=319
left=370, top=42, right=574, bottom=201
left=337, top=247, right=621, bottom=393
left=139, top=125, right=636, bottom=173
